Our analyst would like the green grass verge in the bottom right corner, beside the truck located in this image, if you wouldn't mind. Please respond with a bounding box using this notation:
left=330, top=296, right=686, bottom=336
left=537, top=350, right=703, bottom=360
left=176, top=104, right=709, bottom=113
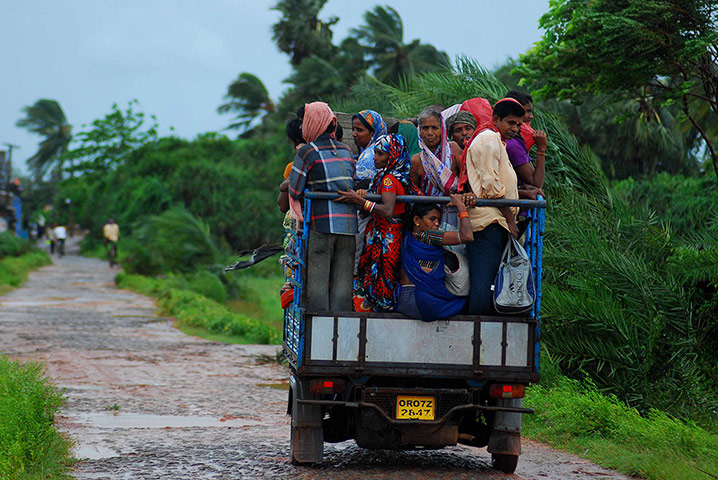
left=523, top=362, right=718, bottom=480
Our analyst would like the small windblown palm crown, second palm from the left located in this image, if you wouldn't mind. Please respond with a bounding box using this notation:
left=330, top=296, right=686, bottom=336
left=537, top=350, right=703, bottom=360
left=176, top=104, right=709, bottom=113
left=217, top=72, right=275, bottom=129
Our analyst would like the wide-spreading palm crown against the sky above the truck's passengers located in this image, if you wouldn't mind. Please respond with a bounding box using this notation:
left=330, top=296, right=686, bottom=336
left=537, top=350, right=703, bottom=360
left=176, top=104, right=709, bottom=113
left=352, top=6, right=450, bottom=85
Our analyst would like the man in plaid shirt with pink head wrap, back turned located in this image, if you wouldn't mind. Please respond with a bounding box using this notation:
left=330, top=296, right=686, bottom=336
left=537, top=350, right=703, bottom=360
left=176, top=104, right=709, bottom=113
left=289, top=102, right=357, bottom=312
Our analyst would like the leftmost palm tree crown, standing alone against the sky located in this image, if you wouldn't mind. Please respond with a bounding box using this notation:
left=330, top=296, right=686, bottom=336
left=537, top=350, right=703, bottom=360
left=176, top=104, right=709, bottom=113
left=16, top=98, right=72, bottom=179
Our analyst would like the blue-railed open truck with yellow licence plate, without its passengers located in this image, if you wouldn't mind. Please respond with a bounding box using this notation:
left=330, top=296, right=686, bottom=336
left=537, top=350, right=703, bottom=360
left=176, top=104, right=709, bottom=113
left=283, top=192, right=546, bottom=473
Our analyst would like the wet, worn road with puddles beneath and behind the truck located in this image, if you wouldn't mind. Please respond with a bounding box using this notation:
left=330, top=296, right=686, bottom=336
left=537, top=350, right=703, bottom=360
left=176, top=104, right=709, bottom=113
left=0, top=244, right=628, bottom=480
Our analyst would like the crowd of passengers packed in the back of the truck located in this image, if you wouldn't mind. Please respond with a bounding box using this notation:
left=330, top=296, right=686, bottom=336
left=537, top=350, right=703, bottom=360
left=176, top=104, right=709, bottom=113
left=278, top=91, right=547, bottom=321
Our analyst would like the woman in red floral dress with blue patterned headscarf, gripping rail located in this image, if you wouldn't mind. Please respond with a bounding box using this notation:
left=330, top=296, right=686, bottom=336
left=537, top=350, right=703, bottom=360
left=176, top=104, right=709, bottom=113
left=338, top=134, right=418, bottom=312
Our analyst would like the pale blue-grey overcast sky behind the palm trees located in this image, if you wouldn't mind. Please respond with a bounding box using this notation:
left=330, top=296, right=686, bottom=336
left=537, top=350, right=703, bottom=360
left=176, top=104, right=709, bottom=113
left=0, top=0, right=548, bottom=170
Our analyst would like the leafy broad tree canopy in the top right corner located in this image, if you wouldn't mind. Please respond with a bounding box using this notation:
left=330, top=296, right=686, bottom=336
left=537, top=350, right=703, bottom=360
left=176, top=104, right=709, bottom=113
left=519, top=0, right=718, bottom=178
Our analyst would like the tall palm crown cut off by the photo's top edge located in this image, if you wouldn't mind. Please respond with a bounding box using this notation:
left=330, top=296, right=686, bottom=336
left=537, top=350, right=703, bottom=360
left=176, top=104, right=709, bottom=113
left=272, top=0, right=339, bottom=67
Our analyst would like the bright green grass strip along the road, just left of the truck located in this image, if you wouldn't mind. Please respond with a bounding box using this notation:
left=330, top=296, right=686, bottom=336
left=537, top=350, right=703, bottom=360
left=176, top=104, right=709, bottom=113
left=115, top=272, right=281, bottom=344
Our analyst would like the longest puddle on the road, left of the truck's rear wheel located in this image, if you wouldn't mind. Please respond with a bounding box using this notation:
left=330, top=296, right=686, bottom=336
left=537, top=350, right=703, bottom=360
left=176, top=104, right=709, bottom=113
left=64, top=412, right=260, bottom=428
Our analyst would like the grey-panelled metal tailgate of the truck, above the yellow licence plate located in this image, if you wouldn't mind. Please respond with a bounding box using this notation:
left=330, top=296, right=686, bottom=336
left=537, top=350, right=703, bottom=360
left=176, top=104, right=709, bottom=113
left=285, top=313, right=538, bottom=381
